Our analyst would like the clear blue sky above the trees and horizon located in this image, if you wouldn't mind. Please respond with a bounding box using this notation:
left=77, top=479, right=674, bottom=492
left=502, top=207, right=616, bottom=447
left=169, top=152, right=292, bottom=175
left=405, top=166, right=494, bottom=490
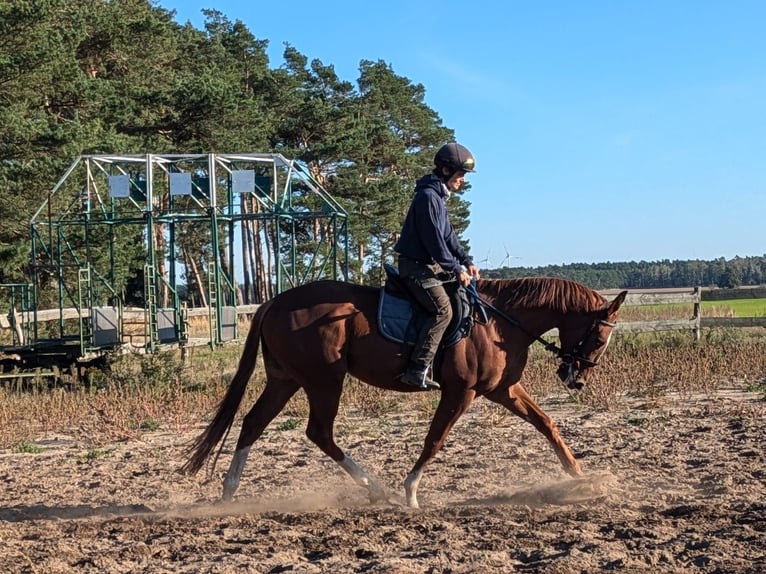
left=156, top=0, right=766, bottom=268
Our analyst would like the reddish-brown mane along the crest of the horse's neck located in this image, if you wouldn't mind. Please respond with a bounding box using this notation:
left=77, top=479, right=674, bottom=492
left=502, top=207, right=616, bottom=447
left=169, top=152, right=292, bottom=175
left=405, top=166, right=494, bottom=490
left=477, top=277, right=605, bottom=313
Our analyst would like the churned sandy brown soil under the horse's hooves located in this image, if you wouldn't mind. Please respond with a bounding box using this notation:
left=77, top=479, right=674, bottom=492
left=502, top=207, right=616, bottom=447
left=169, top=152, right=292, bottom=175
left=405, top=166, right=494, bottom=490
left=0, top=392, right=766, bottom=573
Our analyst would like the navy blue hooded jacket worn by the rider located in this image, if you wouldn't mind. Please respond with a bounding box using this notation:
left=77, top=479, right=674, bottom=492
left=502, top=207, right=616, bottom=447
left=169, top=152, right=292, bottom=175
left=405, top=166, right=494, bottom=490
left=394, top=173, right=472, bottom=274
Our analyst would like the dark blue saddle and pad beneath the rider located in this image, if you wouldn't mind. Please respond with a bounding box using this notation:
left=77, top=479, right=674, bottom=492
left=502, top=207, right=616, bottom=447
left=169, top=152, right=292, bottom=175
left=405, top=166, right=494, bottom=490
left=378, top=264, right=473, bottom=353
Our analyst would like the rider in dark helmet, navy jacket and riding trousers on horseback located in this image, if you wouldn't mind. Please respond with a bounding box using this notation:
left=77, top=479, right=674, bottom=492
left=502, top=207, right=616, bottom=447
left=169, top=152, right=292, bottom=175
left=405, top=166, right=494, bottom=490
left=394, top=142, right=479, bottom=389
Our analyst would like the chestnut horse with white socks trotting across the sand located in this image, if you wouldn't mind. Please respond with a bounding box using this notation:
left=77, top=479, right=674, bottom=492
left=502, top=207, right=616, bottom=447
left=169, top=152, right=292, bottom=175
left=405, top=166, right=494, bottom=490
left=181, top=278, right=627, bottom=508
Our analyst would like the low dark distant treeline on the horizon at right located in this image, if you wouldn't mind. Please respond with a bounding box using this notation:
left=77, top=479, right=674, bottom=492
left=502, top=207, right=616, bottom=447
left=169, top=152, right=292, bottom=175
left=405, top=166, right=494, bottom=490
left=482, top=255, right=766, bottom=289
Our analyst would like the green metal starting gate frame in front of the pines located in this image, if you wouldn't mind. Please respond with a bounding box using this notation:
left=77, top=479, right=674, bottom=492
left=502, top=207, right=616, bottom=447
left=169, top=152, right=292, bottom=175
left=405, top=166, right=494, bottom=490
left=0, top=153, right=349, bottom=380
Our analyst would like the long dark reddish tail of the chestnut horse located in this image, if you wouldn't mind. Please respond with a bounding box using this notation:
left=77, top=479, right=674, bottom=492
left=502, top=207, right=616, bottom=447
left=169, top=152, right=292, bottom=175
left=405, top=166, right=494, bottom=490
left=181, top=301, right=271, bottom=480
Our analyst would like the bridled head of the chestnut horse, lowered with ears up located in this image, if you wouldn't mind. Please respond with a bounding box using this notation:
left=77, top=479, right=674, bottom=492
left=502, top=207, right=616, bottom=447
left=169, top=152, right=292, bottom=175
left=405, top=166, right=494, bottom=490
left=557, top=291, right=628, bottom=390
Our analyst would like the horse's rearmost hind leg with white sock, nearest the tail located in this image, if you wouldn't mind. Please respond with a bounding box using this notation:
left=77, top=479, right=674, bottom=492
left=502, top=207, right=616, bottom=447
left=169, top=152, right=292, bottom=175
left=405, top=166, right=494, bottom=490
left=222, top=378, right=300, bottom=500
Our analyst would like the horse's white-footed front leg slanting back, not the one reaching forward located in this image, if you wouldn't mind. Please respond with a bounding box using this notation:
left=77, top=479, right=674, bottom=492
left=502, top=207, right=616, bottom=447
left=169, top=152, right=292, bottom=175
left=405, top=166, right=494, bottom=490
left=404, top=389, right=475, bottom=508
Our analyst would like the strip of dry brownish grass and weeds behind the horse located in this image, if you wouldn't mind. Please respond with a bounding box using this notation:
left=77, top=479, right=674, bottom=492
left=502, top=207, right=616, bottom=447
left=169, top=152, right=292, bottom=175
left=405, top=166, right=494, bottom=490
left=0, top=330, right=766, bottom=448
